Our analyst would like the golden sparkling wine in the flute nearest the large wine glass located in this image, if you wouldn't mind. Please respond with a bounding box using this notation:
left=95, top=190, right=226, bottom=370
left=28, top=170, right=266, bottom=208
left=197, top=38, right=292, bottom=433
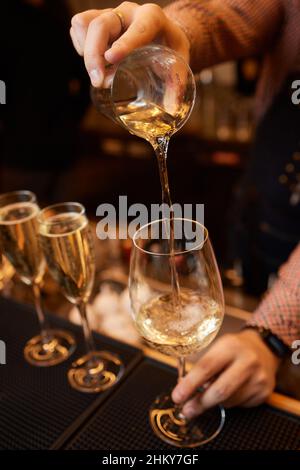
left=40, top=212, right=95, bottom=304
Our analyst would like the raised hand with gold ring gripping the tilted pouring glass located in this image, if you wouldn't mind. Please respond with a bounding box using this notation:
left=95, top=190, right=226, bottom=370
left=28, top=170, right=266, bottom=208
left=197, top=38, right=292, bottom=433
left=70, top=2, right=189, bottom=87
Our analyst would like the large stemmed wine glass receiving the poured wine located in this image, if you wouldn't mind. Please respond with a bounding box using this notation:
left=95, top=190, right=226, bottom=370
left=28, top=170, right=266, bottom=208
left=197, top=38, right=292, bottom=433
left=129, top=218, right=225, bottom=447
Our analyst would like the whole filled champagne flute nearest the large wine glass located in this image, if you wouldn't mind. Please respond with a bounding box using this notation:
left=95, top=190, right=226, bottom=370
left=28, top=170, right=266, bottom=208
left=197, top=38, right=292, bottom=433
left=39, top=202, right=124, bottom=393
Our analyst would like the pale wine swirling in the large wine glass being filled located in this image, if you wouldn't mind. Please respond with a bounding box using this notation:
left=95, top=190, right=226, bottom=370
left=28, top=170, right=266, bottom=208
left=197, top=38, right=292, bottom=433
left=136, top=288, right=223, bottom=357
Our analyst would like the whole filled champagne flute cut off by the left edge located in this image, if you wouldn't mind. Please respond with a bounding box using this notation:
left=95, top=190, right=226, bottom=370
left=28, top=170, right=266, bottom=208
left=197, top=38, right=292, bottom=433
left=0, top=191, right=76, bottom=366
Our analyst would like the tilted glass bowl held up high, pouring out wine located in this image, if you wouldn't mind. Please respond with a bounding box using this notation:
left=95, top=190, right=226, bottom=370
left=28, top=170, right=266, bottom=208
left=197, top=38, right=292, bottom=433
left=91, top=44, right=196, bottom=143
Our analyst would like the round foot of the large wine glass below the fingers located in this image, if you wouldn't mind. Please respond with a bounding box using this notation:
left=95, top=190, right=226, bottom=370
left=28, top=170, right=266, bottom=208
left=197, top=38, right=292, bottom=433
left=149, top=394, right=225, bottom=447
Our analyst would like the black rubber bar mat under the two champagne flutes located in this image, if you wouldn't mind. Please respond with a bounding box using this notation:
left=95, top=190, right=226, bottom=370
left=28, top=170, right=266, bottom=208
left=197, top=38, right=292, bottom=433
left=0, top=297, right=142, bottom=449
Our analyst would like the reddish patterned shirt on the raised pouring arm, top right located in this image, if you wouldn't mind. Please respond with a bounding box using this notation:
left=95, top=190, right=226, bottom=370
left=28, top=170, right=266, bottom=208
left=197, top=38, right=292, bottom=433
left=165, top=0, right=300, bottom=116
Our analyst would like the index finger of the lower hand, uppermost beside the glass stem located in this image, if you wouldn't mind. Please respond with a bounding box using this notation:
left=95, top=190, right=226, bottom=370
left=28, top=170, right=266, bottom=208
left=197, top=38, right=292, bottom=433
left=172, top=336, right=233, bottom=403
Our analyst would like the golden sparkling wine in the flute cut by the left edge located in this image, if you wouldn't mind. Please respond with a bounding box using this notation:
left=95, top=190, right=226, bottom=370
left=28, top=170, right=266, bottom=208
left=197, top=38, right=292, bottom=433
left=0, top=202, right=45, bottom=285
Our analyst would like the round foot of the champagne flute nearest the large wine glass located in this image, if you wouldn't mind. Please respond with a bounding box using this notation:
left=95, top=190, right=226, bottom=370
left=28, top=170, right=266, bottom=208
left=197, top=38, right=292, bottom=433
left=68, top=351, right=124, bottom=393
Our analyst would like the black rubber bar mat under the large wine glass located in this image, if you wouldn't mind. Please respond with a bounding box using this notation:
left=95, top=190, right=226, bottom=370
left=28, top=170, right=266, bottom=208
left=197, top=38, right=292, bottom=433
left=66, top=359, right=300, bottom=450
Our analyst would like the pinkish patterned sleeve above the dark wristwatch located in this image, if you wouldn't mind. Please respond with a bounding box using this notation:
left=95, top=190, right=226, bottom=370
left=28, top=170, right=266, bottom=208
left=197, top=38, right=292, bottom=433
left=248, top=243, right=300, bottom=346
